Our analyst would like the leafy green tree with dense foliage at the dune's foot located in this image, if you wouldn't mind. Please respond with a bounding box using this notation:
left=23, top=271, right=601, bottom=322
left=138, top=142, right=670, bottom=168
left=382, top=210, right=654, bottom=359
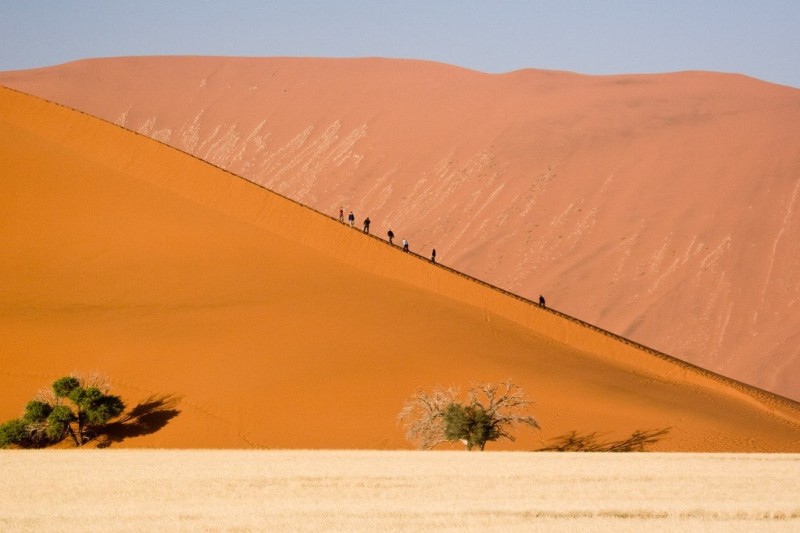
left=0, top=376, right=125, bottom=448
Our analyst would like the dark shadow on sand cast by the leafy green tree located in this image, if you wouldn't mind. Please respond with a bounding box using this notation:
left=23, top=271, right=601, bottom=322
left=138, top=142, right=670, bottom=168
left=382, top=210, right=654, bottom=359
left=97, top=394, right=180, bottom=448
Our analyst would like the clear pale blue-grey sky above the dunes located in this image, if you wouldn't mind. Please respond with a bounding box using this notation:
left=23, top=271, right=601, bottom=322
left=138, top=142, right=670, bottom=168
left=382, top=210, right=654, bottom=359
left=0, top=0, right=800, bottom=88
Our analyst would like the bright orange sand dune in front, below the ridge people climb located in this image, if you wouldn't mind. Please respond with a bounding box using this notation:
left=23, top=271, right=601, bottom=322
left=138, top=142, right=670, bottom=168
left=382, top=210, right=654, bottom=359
left=0, top=89, right=800, bottom=452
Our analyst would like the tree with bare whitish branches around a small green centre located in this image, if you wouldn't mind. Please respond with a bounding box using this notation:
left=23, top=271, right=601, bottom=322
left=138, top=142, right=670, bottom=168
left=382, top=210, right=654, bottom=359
left=398, top=380, right=539, bottom=450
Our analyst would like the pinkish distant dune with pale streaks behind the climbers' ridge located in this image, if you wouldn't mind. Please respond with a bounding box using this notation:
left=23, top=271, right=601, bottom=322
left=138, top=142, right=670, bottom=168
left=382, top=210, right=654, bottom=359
left=0, top=57, right=800, bottom=399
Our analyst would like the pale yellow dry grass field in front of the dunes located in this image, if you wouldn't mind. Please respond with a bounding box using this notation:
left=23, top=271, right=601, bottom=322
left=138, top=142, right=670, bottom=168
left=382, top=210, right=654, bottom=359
left=0, top=450, right=800, bottom=531
